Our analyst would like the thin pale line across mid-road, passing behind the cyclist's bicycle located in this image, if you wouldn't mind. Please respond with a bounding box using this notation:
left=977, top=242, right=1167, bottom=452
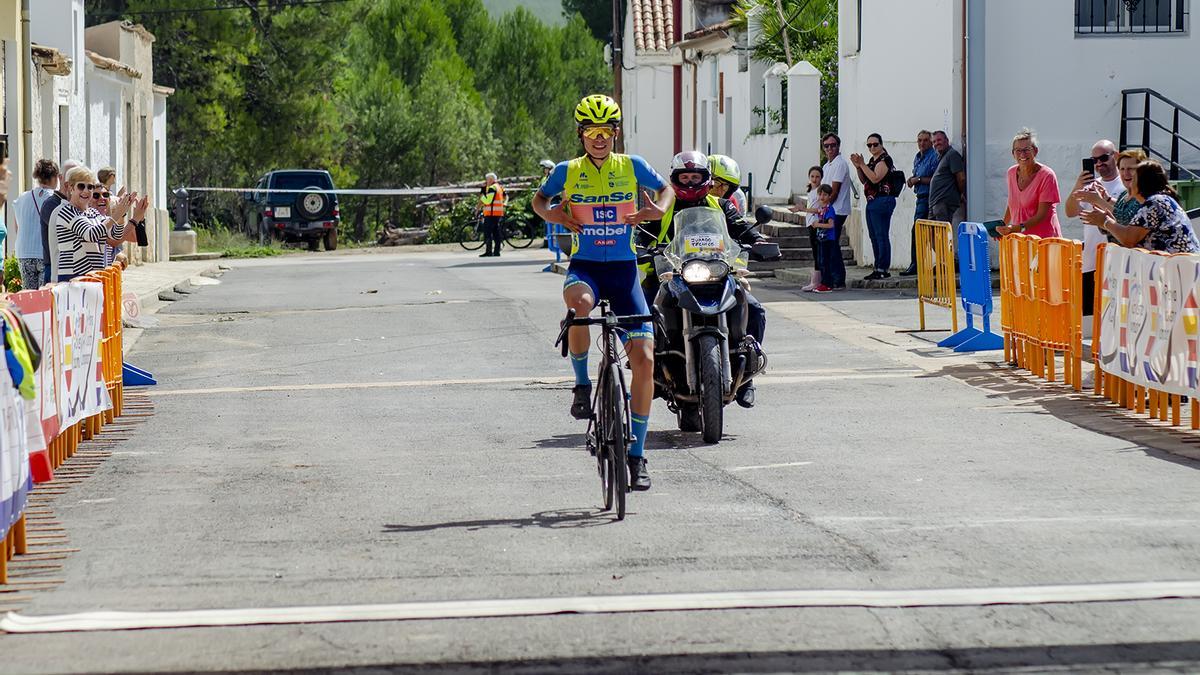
left=146, top=370, right=923, bottom=398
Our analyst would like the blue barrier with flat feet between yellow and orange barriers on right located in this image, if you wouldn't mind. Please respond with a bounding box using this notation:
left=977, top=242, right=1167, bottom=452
left=937, top=222, right=1004, bottom=352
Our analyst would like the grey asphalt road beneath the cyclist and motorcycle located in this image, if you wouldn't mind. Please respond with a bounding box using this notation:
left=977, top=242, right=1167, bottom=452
left=0, top=252, right=1200, bottom=673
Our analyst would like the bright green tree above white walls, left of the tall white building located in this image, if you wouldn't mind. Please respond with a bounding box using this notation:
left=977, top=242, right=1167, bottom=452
left=733, top=0, right=838, bottom=131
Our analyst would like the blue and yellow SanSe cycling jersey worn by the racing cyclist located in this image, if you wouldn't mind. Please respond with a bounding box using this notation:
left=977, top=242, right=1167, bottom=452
left=539, top=153, right=667, bottom=262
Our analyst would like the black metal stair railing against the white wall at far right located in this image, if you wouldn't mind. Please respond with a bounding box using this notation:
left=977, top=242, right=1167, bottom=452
left=1121, top=89, right=1200, bottom=180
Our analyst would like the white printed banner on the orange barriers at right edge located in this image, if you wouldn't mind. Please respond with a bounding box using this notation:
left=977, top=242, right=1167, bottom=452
left=1099, top=246, right=1200, bottom=396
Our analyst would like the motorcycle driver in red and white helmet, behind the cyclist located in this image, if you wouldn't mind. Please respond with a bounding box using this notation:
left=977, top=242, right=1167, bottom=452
left=642, top=150, right=767, bottom=408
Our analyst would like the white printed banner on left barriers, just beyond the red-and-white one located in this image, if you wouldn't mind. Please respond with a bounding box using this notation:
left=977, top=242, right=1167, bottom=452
left=52, top=281, right=113, bottom=428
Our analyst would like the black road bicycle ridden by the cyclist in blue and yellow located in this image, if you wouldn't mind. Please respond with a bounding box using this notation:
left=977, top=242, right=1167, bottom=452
left=554, top=300, right=654, bottom=520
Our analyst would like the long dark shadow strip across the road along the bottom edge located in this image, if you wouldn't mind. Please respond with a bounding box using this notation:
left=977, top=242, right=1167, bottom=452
left=238, top=641, right=1200, bottom=675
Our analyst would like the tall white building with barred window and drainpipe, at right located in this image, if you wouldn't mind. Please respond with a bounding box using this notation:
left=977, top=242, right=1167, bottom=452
left=839, top=0, right=1200, bottom=267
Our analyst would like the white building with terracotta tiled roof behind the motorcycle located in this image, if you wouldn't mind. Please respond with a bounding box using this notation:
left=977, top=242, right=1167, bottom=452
left=622, top=0, right=820, bottom=203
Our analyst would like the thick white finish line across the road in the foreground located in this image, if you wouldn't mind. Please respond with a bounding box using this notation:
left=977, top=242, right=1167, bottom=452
left=0, top=581, right=1200, bottom=633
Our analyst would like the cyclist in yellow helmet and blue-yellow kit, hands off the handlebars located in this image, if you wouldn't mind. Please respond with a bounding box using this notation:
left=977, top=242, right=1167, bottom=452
left=533, top=94, right=674, bottom=490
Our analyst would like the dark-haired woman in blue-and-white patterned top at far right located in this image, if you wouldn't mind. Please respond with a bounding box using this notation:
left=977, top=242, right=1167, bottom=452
left=1100, top=160, right=1200, bottom=253
